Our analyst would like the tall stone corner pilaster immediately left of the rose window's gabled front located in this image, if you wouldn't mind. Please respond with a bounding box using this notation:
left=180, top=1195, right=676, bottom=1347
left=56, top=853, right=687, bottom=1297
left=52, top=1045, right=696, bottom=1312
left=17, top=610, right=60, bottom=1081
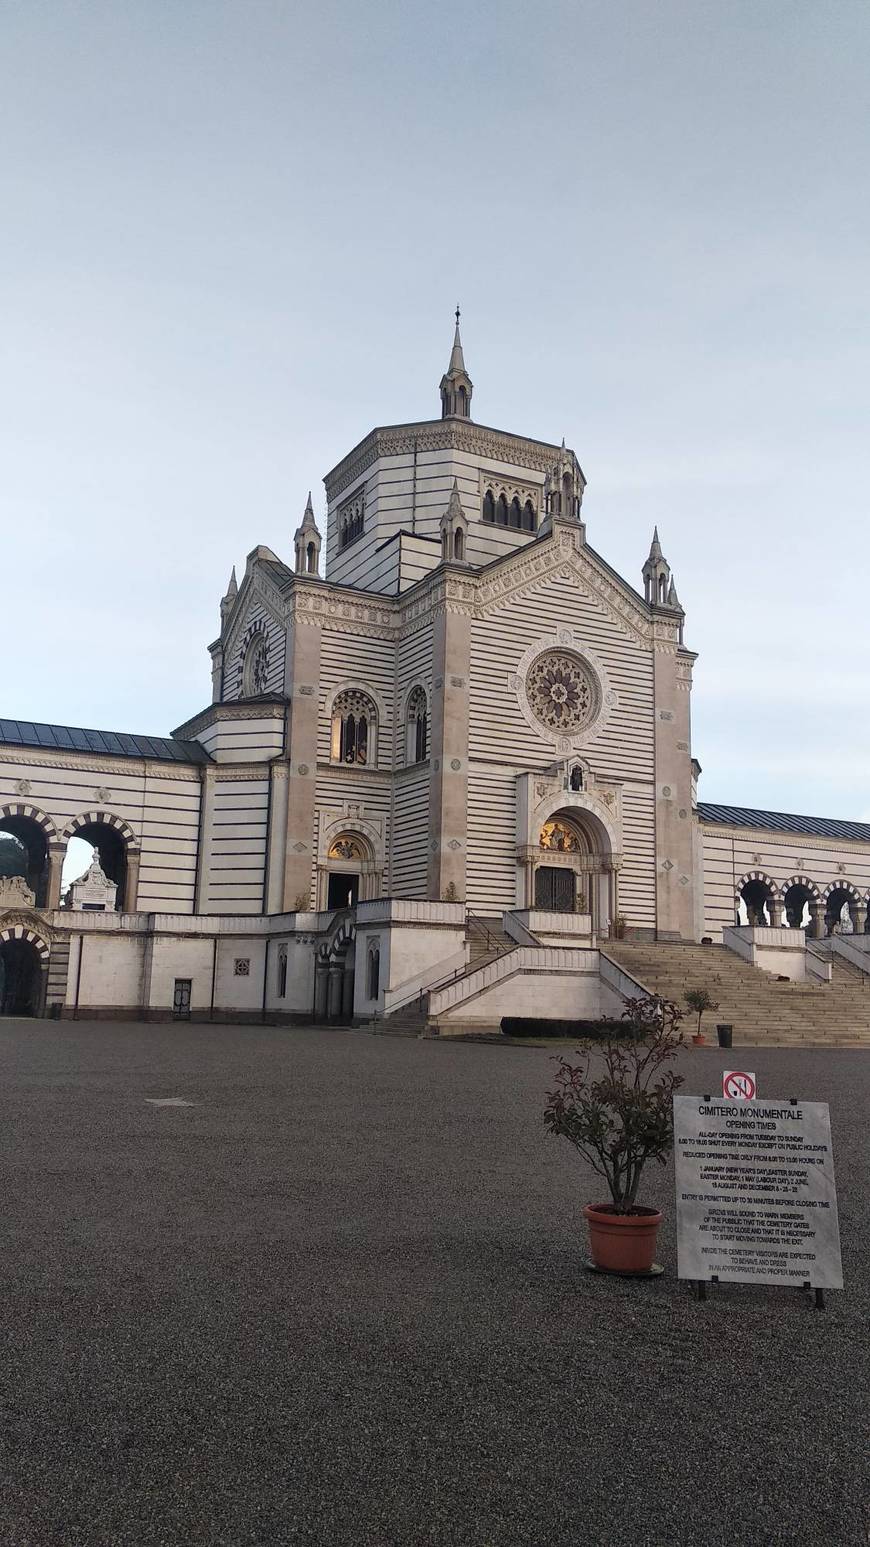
left=429, top=590, right=471, bottom=902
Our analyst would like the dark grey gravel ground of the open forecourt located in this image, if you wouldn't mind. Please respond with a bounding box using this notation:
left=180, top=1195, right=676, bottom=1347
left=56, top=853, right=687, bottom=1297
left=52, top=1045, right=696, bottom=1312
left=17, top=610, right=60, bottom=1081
left=0, top=1021, right=870, bottom=1547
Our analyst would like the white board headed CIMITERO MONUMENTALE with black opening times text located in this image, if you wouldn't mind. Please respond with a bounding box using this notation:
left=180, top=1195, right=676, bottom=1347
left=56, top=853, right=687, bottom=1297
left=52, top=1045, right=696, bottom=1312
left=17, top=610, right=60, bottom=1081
left=673, top=1095, right=842, bottom=1289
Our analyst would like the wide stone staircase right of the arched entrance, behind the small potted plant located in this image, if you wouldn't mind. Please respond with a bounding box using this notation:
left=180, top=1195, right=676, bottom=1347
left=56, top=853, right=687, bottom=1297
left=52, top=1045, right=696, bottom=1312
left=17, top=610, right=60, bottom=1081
left=602, top=941, right=870, bottom=1047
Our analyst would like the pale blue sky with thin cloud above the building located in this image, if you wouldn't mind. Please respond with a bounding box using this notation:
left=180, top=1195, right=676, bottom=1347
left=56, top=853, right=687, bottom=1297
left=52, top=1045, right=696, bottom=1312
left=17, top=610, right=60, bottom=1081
left=0, top=0, right=870, bottom=820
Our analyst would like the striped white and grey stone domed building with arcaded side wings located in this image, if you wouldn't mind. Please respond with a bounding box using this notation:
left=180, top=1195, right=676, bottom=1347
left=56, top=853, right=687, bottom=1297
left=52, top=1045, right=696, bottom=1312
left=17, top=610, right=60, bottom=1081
left=0, top=319, right=870, bottom=1032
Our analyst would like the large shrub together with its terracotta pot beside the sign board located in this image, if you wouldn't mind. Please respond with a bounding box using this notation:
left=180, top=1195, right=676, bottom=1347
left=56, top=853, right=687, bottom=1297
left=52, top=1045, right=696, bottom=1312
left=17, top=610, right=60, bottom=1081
left=543, top=995, right=683, bottom=1273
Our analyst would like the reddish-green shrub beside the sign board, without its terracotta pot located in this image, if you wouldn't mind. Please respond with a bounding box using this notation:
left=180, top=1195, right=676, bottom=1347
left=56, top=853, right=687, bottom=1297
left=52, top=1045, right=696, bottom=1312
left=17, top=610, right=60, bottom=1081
left=543, top=995, right=683, bottom=1214
